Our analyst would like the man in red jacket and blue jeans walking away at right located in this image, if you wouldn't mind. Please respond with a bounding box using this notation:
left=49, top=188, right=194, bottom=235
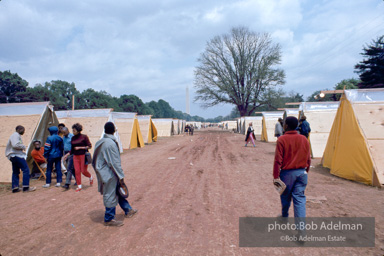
left=273, top=116, right=311, bottom=218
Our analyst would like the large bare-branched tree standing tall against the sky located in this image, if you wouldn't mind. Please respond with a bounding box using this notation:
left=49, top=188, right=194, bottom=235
left=195, top=27, right=285, bottom=116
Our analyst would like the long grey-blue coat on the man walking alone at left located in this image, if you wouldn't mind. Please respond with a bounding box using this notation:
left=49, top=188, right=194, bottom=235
left=92, top=134, right=124, bottom=208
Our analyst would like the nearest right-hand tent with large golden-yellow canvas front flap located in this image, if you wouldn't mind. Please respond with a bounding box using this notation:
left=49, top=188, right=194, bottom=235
left=322, top=89, right=384, bottom=187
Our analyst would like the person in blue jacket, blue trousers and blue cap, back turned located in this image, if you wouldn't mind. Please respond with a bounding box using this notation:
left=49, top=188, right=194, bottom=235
left=43, top=126, right=64, bottom=188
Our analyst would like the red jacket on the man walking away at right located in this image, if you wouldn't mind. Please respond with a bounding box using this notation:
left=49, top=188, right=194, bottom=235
left=273, top=131, right=311, bottom=179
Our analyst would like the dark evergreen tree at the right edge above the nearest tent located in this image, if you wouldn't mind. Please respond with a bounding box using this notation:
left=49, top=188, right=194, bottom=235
left=355, top=35, right=384, bottom=88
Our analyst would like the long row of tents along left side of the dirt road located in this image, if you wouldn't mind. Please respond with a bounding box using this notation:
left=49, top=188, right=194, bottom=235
left=0, top=102, right=186, bottom=183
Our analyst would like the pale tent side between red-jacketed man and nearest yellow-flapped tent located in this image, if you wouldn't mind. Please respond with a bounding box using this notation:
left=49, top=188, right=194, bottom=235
left=300, top=101, right=340, bottom=158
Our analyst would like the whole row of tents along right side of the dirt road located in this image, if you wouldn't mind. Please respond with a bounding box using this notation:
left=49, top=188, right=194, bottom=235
left=223, top=89, right=384, bottom=187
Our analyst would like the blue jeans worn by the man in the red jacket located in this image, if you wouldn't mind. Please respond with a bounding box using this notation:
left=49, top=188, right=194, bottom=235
left=280, top=169, right=308, bottom=218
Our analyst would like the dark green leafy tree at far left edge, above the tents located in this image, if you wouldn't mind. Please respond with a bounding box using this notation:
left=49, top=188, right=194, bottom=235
left=0, top=70, right=28, bottom=103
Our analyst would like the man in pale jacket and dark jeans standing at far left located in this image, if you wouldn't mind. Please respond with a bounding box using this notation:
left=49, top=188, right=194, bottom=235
left=5, top=125, right=36, bottom=193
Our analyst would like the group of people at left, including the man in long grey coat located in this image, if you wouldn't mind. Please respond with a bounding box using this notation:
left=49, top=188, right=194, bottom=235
left=5, top=122, right=137, bottom=226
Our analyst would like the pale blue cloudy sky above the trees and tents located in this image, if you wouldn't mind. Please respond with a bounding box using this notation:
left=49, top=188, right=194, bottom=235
left=0, top=0, right=384, bottom=118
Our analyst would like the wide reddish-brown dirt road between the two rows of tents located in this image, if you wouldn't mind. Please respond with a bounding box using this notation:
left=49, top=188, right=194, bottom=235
left=0, top=129, right=384, bottom=256
